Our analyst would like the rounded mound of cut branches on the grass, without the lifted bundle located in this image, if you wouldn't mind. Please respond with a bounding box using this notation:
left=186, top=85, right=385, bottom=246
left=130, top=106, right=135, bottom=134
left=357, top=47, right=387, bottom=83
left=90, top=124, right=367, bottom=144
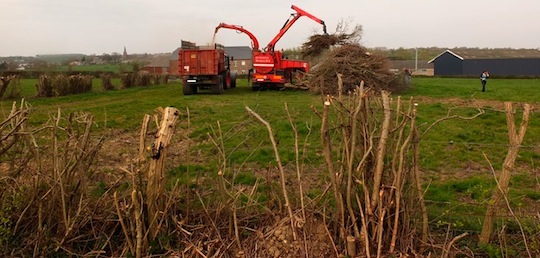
left=307, top=44, right=403, bottom=94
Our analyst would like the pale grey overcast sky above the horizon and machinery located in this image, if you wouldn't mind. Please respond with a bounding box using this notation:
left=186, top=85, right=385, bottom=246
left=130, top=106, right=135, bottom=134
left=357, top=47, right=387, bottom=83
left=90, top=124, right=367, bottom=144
left=0, top=0, right=540, bottom=56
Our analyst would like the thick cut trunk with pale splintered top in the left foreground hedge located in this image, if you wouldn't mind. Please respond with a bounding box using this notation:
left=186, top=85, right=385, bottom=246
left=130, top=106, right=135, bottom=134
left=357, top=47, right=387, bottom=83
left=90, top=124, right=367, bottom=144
left=146, top=107, right=179, bottom=239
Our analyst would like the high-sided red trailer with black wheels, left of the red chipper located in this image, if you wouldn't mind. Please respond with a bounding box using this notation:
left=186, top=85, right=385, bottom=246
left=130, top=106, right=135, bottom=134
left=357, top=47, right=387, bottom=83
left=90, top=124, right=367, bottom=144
left=178, top=41, right=236, bottom=95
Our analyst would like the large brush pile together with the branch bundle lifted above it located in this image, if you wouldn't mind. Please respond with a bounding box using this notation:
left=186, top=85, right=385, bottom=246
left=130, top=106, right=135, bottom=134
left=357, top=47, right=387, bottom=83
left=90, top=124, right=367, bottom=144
left=297, top=21, right=404, bottom=95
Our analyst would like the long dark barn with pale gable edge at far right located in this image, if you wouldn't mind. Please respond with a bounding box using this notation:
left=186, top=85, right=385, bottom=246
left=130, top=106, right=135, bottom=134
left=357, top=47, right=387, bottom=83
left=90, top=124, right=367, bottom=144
left=428, top=49, right=540, bottom=76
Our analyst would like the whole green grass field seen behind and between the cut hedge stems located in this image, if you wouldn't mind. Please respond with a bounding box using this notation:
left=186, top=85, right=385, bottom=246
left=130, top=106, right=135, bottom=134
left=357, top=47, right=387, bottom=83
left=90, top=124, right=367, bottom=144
left=0, top=78, right=540, bottom=255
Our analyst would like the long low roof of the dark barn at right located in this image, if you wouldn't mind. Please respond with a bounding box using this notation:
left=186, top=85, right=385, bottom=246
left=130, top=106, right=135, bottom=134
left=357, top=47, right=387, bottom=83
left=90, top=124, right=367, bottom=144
left=428, top=48, right=540, bottom=63
